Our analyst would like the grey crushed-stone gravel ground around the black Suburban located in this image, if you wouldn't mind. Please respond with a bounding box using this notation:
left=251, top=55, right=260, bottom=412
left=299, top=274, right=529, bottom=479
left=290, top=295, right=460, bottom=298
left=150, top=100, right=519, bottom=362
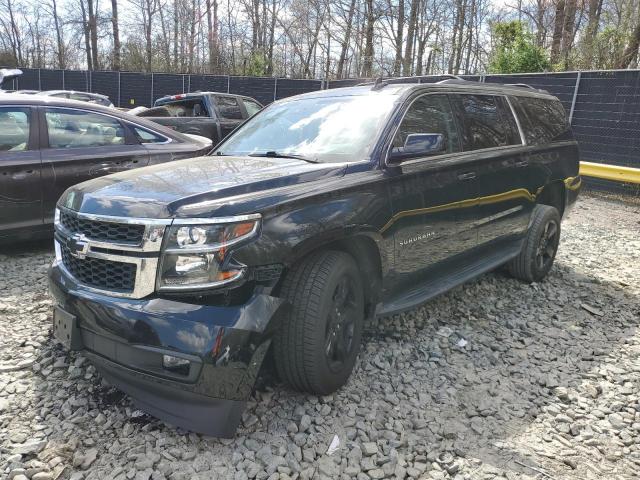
left=0, top=195, right=640, bottom=480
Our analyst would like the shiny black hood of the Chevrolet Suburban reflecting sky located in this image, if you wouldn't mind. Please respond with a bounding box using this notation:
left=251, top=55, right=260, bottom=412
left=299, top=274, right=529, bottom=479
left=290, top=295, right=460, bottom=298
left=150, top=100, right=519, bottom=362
left=58, top=156, right=345, bottom=218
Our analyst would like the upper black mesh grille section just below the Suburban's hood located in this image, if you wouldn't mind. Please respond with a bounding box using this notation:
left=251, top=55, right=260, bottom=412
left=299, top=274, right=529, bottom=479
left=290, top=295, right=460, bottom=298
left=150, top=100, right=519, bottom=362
left=60, top=211, right=145, bottom=245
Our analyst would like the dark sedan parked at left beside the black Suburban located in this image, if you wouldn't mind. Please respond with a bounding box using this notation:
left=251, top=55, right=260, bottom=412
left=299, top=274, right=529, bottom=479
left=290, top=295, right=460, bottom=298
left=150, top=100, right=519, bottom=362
left=0, top=93, right=211, bottom=243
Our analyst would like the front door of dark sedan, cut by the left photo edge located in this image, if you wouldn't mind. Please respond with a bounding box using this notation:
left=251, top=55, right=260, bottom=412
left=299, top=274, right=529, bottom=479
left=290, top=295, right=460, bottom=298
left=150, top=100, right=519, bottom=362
left=0, top=106, right=42, bottom=237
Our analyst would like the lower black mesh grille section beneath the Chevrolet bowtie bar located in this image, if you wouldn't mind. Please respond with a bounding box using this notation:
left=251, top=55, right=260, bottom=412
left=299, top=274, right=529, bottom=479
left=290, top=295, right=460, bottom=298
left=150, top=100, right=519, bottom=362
left=60, top=244, right=136, bottom=292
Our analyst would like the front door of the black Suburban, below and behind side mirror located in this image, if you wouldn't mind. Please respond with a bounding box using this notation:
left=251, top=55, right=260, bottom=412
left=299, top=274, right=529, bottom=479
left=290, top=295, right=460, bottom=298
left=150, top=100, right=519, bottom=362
left=383, top=94, right=476, bottom=290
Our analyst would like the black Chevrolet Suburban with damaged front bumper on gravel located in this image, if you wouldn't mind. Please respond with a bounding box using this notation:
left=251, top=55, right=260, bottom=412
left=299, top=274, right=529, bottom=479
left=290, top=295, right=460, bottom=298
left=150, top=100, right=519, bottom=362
left=49, top=80, right=581, bottom=436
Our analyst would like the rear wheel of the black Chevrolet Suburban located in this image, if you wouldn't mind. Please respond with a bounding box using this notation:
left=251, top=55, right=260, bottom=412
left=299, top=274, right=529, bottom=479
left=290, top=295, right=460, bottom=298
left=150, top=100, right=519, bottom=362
left=508, top=205, right=560, bottom=283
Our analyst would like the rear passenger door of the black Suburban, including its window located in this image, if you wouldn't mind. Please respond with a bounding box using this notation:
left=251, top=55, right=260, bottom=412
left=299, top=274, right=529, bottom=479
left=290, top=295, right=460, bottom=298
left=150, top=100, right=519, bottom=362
left=452, top=94, right=535, bottom=247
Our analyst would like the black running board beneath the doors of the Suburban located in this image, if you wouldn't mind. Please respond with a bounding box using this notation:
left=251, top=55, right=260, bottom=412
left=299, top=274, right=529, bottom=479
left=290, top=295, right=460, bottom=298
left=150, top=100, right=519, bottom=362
left=376, top=240, right=522, bottom=317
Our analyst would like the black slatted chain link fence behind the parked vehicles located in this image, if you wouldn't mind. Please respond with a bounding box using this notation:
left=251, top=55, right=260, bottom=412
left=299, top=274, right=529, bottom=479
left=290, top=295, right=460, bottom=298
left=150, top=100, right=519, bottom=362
left=5, top=69, right=640, bottom=196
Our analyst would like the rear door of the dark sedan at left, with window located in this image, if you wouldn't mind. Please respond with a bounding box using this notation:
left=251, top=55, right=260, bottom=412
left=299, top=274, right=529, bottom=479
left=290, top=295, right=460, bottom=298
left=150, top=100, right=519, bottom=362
left=40, top=107, right=149, bottom=222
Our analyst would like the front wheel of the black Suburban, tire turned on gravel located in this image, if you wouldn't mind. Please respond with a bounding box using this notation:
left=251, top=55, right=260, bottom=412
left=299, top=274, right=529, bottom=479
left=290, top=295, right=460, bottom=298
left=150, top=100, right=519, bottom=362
left=274, top=250, right=364, bottom=395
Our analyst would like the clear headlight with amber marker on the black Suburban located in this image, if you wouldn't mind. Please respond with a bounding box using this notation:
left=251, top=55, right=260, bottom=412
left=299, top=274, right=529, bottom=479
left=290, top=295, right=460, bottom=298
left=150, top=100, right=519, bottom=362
left=158, top=214, right=260, bottom=291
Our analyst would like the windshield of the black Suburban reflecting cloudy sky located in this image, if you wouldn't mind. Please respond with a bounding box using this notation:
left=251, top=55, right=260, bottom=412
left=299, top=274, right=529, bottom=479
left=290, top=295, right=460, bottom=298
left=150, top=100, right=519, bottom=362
left=214, top=95, right=396, bottom=163
